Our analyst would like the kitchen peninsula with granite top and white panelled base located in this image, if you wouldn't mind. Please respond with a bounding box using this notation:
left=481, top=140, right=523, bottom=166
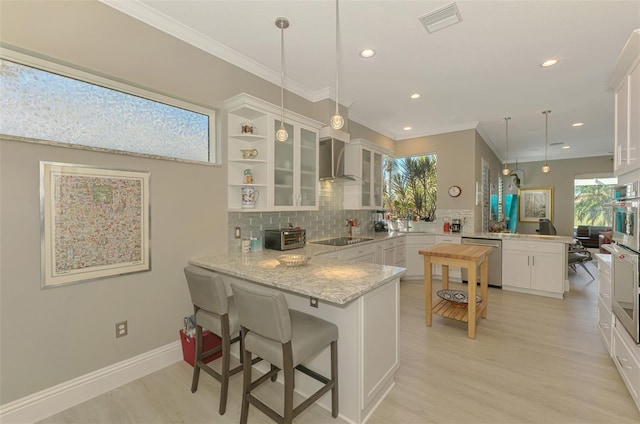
left=189, top=246, right=405, bottom=423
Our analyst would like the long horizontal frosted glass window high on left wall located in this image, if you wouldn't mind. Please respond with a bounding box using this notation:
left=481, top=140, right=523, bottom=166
left=0, top=51, right=217, bottom=162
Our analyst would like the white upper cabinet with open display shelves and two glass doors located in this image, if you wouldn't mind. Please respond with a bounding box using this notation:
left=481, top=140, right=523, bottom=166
left=224, top=94, right=323, bottom=212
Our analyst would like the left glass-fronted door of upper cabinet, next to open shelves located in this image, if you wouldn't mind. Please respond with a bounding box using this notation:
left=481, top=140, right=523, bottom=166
left=273, top=120, right=296, bottom=206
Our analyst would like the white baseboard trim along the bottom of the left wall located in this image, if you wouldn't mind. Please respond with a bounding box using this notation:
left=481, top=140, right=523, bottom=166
left=0, top=341, right=182, bottom=423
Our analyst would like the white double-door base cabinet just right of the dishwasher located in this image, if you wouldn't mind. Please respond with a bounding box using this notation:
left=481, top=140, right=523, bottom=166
left=502, top=240, right=567, bottom=298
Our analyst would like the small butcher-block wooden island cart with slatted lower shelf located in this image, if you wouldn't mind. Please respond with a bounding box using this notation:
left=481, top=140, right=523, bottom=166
left=418, top=244, right=493, bottom=339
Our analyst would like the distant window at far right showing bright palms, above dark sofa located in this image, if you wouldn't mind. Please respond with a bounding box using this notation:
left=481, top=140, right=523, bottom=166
left=573, top=177, right=618, bottom=227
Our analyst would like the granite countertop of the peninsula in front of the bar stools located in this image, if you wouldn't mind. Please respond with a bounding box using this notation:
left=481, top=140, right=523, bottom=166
left=189, top=245, right=406, bottom=305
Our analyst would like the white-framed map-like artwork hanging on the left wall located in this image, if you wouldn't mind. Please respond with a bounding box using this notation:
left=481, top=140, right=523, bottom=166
left=40, top=162, right=151, bottom=287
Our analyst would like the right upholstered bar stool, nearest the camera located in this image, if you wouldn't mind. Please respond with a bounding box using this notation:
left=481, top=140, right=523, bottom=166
left=231, top=283, right=338, bottom=424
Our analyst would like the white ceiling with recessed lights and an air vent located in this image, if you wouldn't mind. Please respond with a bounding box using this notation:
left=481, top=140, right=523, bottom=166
left=101, top=0, right=640, bottom=163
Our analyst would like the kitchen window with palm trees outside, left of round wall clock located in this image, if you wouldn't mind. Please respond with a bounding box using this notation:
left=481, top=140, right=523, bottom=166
left=383, top=154, right=437, bottom=221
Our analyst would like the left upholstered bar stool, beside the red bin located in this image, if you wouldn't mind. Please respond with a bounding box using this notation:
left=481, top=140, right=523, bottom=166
left=184, top=265, right=242, bottom=415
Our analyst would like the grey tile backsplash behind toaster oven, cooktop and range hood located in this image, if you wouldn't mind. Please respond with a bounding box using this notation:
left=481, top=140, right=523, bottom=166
left=227, top=182, right=473, bottom=252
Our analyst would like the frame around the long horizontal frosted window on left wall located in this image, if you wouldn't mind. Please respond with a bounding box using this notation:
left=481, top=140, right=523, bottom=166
left=0, top=46, right=222, bottom=166
